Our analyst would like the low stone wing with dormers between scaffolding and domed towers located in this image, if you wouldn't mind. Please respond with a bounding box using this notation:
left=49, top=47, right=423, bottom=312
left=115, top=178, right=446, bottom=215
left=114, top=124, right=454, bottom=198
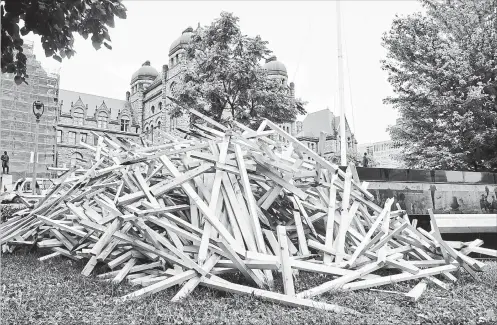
left=55, top=89, right=139, bottom=167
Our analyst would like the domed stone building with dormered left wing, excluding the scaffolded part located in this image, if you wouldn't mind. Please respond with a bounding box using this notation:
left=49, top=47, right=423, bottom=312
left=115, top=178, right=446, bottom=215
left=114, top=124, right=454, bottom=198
left=56, top=27, right=302, bottom=167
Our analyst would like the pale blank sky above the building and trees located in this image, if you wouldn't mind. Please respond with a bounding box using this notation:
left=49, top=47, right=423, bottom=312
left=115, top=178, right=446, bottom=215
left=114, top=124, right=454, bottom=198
left=28, top=0, right=422, bottom=144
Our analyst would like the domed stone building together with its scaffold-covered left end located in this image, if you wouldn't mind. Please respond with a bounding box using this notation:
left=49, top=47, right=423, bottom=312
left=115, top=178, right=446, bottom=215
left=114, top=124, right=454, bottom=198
left=0, top=27, right=303, bottom=177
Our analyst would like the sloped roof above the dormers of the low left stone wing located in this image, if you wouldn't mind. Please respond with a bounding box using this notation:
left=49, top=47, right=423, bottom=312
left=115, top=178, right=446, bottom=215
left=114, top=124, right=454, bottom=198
left=59, top=89, right=126, bottom=120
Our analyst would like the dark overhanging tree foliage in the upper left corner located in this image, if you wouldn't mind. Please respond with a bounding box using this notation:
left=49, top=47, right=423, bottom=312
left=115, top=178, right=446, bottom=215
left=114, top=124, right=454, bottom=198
left=0, top=0, right=126, bottom=84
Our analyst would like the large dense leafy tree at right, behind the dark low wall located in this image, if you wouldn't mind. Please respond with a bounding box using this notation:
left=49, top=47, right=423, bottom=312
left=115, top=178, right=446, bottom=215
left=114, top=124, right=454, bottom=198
left=382, top=0, right=497, bottom=171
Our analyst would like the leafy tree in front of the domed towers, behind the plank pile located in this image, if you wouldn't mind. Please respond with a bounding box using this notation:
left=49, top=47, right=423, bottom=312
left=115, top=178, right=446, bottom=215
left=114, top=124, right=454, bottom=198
left=173, top=12, right=305, bottom=127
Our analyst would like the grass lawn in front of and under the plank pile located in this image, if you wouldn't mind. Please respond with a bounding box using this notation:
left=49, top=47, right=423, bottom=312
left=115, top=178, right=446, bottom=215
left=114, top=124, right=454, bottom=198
left=0, top=252, right=497, bottom=325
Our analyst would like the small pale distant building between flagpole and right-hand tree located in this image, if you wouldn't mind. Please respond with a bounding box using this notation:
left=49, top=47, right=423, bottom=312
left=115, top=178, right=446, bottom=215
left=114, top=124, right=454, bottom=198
left=359, top=140, right=405, bottom=168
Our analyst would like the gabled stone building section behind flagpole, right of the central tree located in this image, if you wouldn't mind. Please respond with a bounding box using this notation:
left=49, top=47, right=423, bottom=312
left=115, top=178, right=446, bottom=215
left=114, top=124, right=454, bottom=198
left=297, top=108, right=357, bottom=163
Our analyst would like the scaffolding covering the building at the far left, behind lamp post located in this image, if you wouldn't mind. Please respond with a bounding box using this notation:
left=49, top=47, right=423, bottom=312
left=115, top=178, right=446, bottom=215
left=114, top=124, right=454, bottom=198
left=0, top=42, right=60, bottom=181
